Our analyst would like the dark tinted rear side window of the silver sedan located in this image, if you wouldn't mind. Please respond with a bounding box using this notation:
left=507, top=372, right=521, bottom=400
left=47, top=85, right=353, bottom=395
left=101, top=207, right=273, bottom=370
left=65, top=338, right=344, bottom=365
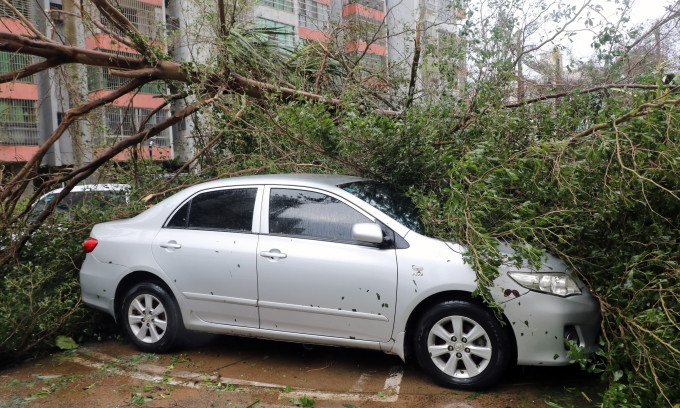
left=166, top=188, right=257, bottom=231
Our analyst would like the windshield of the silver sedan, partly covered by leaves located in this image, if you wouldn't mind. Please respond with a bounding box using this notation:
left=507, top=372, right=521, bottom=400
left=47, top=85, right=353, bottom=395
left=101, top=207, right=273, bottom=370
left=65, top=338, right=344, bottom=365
left=338, top=180, right=425, bottom=234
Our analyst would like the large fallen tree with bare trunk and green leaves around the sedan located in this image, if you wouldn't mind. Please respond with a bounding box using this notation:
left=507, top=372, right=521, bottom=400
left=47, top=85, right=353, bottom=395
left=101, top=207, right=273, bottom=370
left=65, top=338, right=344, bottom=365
left=0, top=0, right=680, bottom=406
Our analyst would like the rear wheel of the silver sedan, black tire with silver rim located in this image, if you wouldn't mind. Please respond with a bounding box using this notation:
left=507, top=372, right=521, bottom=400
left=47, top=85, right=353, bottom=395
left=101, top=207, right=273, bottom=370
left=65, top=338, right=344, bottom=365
left=121, top=282, right=184, bottom=353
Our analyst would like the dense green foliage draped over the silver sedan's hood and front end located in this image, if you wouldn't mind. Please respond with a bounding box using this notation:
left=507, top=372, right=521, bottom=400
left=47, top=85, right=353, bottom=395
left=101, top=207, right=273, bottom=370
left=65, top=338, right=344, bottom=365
left=404, top=88, right=680, bottom=406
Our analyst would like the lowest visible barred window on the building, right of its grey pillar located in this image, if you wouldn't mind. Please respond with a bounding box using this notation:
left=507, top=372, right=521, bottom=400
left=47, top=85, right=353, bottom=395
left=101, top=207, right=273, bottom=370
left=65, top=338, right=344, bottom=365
left=99, top=106, right=170, bottom=146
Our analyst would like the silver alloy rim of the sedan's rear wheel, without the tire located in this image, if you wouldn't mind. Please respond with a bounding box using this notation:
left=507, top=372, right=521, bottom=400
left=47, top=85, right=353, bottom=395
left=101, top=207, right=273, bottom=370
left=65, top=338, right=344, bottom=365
left=128, top=293, right=168, bottom=344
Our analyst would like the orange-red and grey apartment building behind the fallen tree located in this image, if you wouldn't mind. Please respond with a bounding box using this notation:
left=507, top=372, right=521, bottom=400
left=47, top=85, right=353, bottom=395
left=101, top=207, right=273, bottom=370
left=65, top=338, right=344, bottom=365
left=0, top=0, right=460, bottom=167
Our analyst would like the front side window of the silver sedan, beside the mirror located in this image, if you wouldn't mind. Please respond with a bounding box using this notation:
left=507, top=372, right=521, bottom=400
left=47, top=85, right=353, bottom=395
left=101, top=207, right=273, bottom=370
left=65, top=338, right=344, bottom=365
left=269, top=189, right=371, bottom=242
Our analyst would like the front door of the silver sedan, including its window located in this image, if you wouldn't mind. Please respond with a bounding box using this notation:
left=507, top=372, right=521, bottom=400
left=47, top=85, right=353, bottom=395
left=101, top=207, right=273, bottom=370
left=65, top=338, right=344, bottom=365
left=257, top=187, right=397, bottom=341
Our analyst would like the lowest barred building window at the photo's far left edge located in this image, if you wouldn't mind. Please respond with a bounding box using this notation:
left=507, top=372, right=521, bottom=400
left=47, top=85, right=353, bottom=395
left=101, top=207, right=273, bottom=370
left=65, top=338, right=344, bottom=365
left=0, top=99, right=39, bottom=145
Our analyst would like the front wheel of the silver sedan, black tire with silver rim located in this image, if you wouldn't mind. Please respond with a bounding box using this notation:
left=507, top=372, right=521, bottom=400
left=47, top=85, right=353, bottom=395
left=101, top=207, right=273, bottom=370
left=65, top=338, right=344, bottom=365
left=414, top=300, right=512, bottom=390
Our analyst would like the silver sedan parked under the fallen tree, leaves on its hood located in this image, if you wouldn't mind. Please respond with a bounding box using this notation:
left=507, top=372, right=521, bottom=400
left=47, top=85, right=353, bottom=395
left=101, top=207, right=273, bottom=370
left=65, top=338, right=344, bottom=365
left=80, top=175, right=599, bottom=389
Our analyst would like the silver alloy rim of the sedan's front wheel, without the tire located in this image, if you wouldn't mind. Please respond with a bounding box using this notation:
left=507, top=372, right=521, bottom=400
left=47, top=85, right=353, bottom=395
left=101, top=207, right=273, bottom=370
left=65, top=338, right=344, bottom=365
left=427, top=316, right=492, bottom=379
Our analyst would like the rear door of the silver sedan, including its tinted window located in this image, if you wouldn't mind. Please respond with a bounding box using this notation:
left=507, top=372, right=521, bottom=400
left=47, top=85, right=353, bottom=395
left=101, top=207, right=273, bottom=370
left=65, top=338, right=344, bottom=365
left=152, top=187, right=262, bottom=327
